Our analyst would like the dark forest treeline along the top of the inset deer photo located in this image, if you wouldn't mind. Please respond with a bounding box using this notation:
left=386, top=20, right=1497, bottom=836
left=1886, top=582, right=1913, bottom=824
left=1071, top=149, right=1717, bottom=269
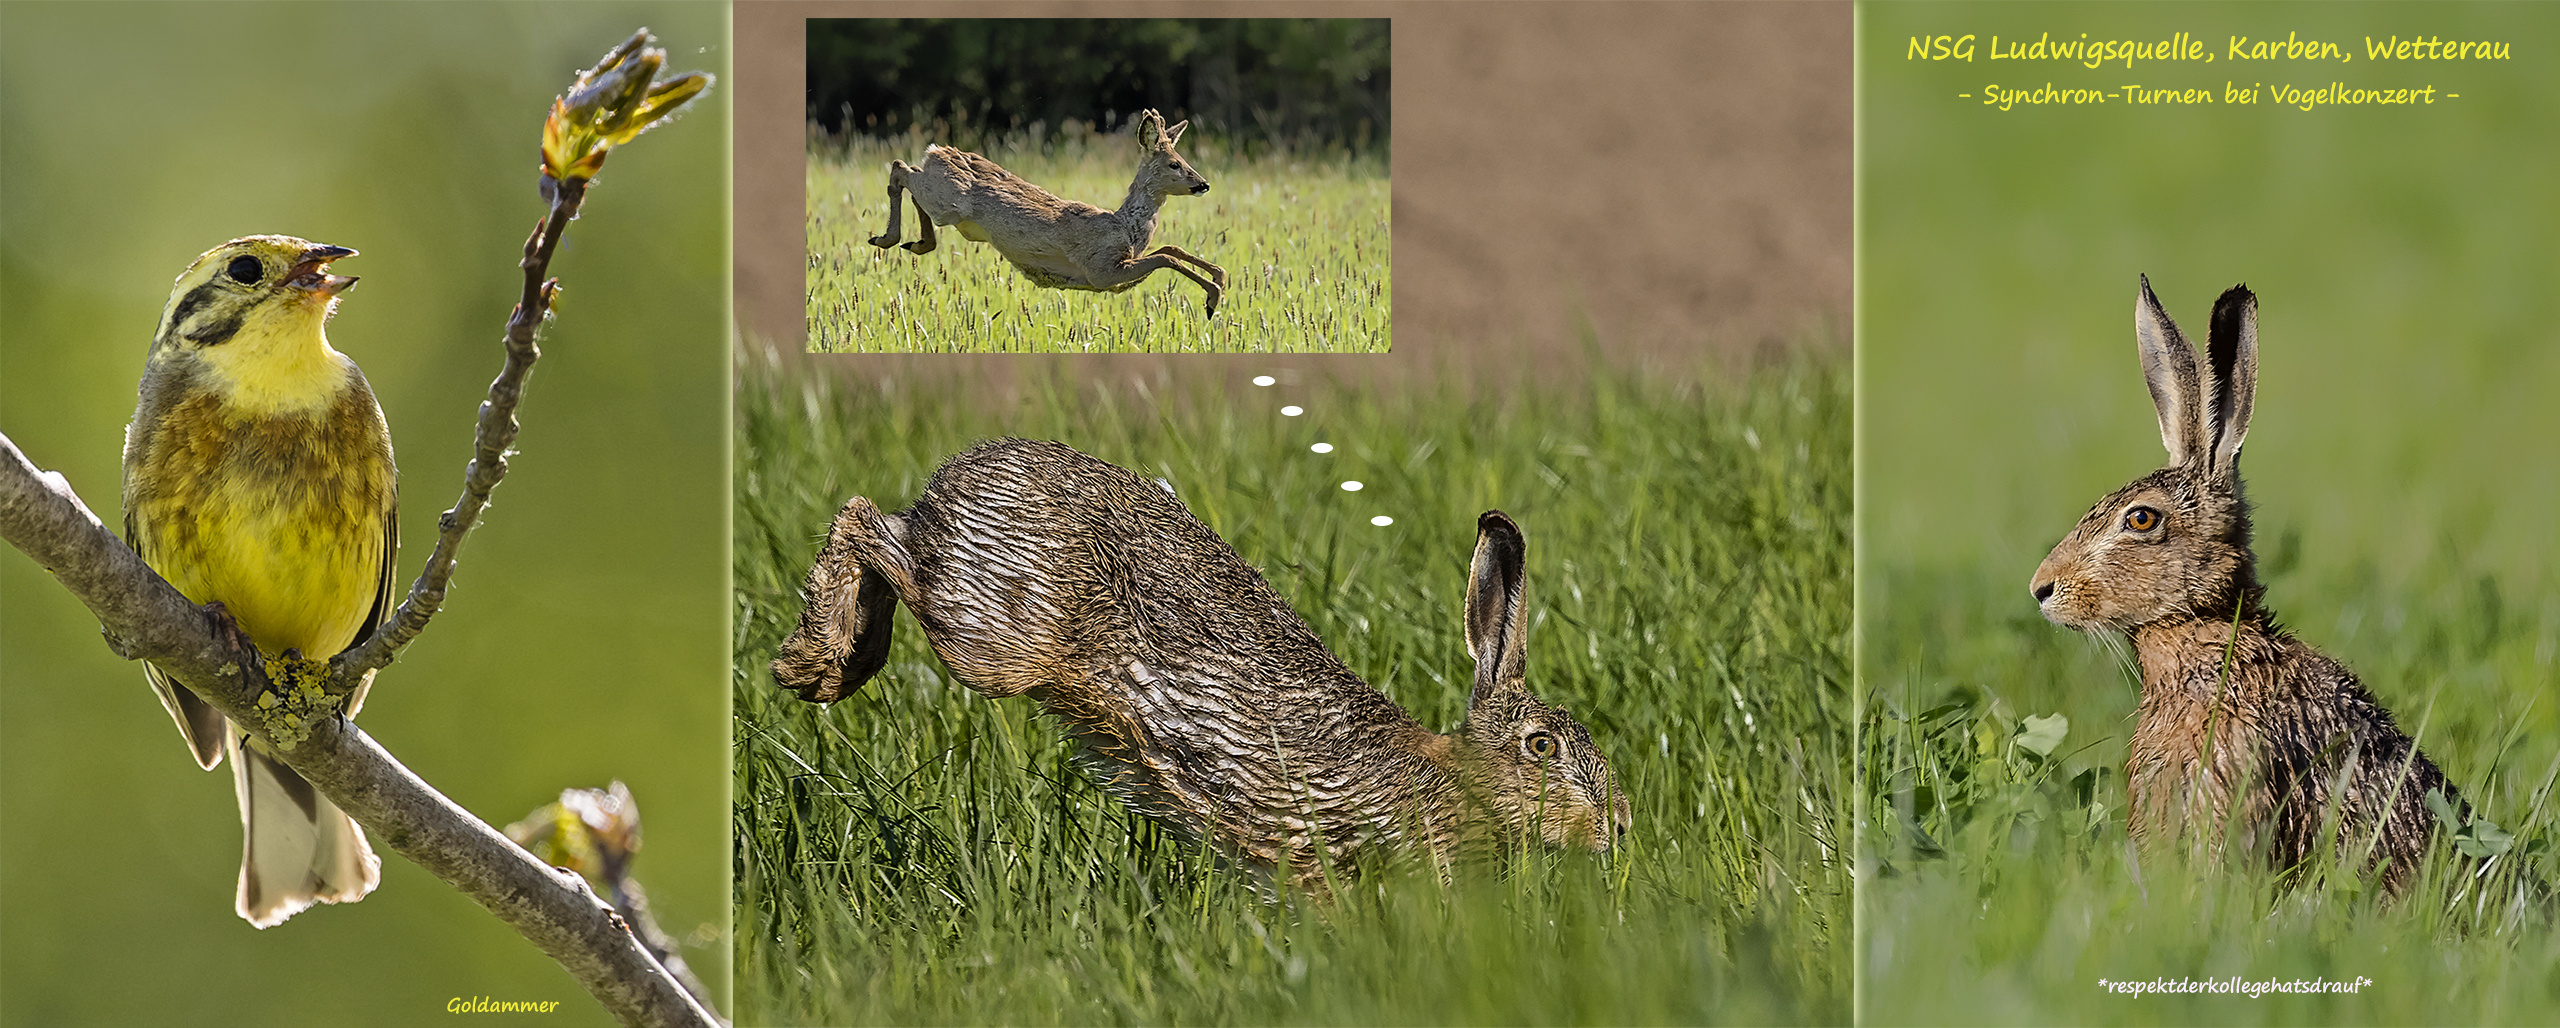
left=809, top=18, right=1390, bottom=151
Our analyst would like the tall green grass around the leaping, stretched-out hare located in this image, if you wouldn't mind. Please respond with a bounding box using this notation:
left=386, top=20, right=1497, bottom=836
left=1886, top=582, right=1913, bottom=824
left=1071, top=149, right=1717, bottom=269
left=735, top=347, right=1848, bottom=1023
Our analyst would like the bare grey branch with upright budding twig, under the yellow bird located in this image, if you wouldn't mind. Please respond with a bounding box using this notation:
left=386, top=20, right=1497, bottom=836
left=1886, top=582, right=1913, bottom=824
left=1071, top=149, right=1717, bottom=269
left=0, top=28, right=719, bottom=1025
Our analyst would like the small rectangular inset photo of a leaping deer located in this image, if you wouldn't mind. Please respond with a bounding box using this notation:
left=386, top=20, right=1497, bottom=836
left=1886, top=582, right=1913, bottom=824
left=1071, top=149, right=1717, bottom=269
left=806, top=18, right=1393, bottom=353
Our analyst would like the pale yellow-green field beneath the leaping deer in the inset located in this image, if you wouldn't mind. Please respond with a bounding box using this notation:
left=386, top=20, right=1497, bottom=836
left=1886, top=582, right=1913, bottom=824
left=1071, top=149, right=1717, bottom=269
left=809, top=130, right=1390, bottom=353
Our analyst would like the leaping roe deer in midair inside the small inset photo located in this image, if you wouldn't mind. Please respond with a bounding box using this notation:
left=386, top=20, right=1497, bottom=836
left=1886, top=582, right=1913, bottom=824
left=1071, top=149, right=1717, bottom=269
left=870, top=110, right=1226, bottom=317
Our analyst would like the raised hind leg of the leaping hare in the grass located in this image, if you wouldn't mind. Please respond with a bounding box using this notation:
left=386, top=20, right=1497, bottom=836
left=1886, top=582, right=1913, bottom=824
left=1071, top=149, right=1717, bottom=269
left=773, top=496, right=899, bottom=703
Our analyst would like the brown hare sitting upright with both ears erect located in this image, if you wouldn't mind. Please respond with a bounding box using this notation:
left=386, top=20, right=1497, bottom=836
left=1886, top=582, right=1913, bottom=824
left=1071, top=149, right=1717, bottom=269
left=2030, top=279, right=2468, bottom=892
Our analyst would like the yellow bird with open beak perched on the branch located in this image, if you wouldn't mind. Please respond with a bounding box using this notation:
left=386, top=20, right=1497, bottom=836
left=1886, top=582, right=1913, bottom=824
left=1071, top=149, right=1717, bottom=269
left=125, top=235, right=399, bottom=928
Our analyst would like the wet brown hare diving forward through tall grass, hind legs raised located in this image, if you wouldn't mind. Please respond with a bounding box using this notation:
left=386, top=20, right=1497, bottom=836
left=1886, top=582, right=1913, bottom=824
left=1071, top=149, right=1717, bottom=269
left=773, top=440, right=1628, bottom=887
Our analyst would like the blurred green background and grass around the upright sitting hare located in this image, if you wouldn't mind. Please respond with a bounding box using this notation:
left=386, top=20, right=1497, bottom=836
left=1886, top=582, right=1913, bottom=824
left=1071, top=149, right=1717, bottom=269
left=1859, top=5, right=2560, bottom=1023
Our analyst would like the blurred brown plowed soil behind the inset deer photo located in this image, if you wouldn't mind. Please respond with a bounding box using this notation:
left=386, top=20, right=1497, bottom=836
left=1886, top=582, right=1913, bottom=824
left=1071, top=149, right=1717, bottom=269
left=732, top=3, right=1853, bottom=378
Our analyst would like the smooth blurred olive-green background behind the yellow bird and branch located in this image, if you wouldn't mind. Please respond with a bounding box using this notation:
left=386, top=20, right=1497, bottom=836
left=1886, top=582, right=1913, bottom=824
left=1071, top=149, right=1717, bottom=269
left=0, top=3, right=727, bottom=1025
